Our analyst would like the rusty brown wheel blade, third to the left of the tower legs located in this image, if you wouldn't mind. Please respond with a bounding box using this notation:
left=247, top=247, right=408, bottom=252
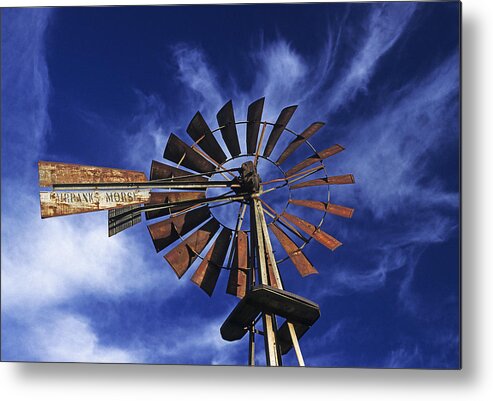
left=164, top=218, right=219, bottom=278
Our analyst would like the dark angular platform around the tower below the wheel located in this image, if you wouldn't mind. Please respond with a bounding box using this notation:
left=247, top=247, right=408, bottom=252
left=221, top=284, right=320, bottom=341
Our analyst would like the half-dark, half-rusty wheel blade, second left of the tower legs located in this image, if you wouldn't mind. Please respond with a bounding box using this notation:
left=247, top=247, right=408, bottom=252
left=191, top=228, right=232, bottom=296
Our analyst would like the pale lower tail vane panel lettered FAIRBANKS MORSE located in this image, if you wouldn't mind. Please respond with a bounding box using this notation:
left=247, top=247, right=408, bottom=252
left=39, top=189, right=151, bottom=219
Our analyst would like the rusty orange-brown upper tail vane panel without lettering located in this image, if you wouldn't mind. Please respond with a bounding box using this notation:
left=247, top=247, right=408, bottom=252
left=38, top=161, right=147, bottom=187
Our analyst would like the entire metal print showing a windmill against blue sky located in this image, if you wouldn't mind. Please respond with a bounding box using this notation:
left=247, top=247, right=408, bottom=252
left=1, top=1, right=461, bottom=369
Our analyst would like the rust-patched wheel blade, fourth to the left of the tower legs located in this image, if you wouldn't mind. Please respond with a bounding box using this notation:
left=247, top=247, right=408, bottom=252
left=147, top=206, right=211, bottom=252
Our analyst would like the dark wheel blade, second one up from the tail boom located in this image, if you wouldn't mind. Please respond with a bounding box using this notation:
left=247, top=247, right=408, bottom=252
left=163, top=134, right=215, bottom=177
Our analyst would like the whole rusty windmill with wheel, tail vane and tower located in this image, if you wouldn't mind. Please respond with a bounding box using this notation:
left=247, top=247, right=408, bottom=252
left=38, top=98, right=354, bottom=366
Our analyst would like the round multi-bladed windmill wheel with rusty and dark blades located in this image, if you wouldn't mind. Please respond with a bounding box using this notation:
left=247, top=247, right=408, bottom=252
left=146, top=98, right=354, bottom=298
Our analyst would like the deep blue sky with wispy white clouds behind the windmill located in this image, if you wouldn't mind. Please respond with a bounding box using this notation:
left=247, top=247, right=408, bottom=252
left=1, top=2, right=460, bottom=368
